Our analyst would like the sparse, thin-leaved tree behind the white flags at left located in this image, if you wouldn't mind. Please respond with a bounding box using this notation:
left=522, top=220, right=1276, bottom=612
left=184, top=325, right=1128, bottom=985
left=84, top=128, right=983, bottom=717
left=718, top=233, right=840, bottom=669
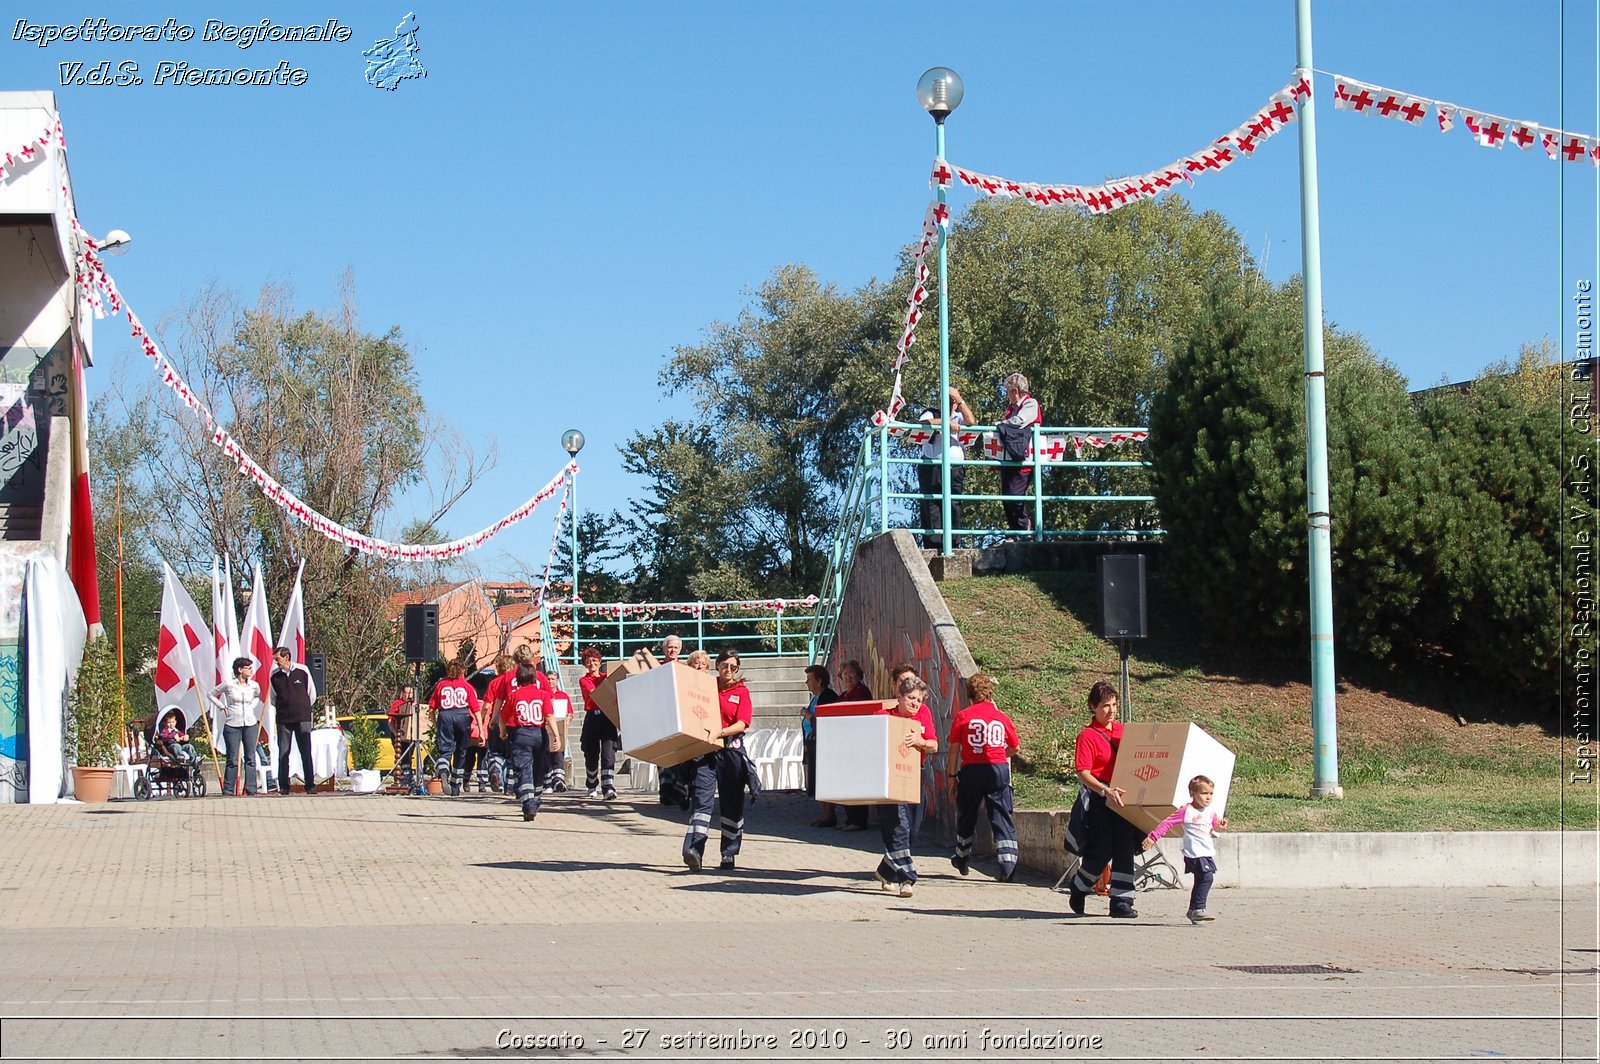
left=94, top=278, right=488, bottom=710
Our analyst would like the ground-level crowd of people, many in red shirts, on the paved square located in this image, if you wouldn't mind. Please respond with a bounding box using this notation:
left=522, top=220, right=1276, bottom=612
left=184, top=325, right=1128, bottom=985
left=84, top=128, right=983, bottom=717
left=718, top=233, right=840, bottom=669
left=374, top=635, right=1227, bottom=923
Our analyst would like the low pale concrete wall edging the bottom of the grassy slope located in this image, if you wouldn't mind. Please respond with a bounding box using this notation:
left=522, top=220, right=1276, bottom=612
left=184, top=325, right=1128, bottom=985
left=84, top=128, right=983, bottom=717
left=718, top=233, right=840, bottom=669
left=1016, top=810, right=1600, bottom=893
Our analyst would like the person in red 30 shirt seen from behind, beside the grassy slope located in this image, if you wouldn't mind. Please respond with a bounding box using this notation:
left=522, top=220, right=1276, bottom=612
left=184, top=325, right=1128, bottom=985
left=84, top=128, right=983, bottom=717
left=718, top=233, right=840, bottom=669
left=949, top=672, right=1021, bottom=883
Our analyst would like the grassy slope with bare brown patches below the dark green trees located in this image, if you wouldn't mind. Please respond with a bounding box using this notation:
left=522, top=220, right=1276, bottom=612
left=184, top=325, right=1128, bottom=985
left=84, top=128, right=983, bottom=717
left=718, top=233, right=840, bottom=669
left=941, top=573, right=1597, bottom=830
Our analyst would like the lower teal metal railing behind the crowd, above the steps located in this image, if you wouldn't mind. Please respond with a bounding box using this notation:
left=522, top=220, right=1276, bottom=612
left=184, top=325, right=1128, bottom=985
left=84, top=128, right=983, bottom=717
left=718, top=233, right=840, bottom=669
left=539, top=600, right=816, bottom=670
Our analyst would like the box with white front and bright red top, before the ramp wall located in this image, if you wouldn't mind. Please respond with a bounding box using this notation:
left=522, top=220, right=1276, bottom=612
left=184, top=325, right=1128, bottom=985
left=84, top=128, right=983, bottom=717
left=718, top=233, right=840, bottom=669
left=816, top=701, right=922, bottom=805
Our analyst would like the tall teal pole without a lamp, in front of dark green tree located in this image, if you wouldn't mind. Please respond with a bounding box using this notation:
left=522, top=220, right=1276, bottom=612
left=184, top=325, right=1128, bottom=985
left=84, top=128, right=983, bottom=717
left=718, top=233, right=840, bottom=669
left=1294, top=0, right=1344, bottom=798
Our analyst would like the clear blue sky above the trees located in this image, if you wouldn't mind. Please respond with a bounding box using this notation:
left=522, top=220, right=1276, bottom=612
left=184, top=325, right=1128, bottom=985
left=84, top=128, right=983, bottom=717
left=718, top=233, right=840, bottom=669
left=0, top=0, right=1600, bottom=574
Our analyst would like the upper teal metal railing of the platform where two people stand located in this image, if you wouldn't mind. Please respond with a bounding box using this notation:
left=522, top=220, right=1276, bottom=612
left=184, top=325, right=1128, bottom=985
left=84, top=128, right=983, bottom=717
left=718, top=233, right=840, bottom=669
left=811, top=422, right=1163, bottom=661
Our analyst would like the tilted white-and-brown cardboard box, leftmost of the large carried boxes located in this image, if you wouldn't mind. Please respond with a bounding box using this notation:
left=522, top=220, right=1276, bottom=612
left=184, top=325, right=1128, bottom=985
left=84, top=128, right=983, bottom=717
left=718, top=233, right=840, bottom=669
left=616, top=661, right=722, bottom=768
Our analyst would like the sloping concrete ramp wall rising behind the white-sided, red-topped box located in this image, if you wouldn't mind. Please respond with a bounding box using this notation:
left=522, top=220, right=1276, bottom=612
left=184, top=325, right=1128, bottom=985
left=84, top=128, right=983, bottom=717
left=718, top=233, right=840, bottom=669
left=827, top=530, right=978, bottom=834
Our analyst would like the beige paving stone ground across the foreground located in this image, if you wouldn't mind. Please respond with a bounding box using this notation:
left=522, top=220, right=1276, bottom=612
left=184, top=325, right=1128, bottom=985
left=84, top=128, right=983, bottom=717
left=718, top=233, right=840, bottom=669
left=0, top=794, right=1600, bottom=1061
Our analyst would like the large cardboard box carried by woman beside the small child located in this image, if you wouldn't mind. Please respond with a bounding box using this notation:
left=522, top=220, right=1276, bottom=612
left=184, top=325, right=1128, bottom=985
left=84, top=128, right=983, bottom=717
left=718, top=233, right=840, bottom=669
left=1110, top=723, right=1234, bottom=832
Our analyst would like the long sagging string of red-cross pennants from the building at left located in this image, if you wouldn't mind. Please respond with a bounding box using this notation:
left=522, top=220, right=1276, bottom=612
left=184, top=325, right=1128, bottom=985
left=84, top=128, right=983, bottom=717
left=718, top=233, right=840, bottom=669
left=0, top=118, right=578, bottom=563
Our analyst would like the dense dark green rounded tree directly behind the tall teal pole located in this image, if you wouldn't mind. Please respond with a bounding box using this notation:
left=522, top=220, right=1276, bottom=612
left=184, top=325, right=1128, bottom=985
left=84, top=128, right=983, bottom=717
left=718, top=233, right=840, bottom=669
left=1150, top=278, right=1435, bottom=658
